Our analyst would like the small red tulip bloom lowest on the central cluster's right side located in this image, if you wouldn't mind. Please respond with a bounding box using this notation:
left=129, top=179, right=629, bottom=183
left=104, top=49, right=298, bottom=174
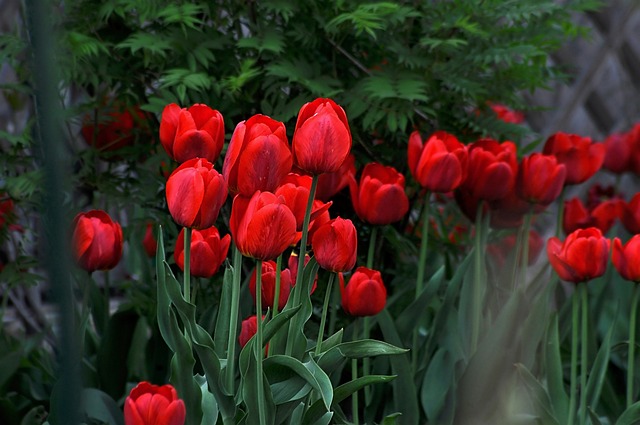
left=340, top=267, right=387, bottom=317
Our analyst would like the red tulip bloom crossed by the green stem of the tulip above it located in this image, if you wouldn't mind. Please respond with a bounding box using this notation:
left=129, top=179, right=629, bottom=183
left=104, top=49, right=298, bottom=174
left=173, top=227, right=231, bottom=277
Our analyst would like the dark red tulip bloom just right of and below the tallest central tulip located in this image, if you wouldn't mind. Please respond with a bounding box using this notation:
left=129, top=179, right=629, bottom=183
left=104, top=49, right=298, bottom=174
left=349, top=162, right=409, bottom=225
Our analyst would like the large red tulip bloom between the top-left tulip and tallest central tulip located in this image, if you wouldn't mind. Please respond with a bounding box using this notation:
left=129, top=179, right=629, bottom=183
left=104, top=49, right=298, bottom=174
left=222, top=115, right=292, bottom=197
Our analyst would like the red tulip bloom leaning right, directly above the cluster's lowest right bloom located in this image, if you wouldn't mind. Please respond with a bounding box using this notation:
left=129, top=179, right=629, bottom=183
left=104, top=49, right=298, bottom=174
left=311, top=217, right=358, bottom=272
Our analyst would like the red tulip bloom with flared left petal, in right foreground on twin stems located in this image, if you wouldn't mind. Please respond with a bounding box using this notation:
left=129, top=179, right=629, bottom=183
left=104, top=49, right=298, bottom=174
left=547, top=227, right=610, bottom=283
